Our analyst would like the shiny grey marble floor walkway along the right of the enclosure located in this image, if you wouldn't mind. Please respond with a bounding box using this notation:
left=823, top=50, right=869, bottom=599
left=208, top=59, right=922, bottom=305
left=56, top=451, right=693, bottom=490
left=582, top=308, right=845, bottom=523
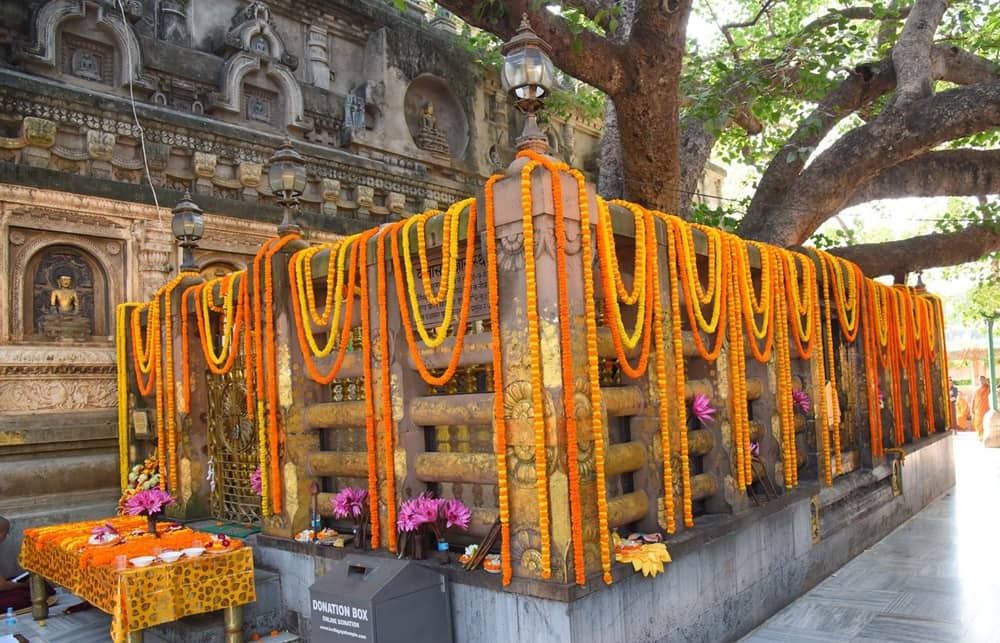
left=741, top=433, right=1000, bottom=643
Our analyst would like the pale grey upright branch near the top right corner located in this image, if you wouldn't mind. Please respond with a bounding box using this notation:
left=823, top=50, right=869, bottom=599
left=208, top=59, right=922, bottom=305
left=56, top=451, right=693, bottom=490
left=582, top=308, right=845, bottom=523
left=892, top=0, right=948, bottom=107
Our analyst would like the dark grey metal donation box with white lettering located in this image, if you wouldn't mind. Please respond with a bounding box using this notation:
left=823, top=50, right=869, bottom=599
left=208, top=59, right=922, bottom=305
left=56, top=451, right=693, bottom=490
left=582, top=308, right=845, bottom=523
left=309, top=554, right=454, bottom=643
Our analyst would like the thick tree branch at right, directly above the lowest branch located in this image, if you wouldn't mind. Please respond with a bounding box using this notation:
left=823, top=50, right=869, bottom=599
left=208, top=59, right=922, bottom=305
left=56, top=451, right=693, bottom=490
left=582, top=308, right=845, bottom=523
left=845, top=150, right=1000, bottom=207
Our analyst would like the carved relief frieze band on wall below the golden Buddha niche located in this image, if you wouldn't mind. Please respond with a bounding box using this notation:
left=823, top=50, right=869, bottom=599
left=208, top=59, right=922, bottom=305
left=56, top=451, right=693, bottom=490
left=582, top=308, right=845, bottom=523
left=0, top=378, right=118, bottom=412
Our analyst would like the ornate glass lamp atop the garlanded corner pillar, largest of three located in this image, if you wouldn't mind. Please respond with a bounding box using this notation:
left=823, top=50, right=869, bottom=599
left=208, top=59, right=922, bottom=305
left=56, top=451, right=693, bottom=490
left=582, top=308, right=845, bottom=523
left=500, top=14, right=556, bottom=154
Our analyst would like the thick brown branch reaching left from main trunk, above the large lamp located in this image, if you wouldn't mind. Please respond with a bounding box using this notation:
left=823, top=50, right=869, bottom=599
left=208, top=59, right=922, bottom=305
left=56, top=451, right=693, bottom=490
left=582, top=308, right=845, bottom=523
left=438, top=0, right=626, bottom=94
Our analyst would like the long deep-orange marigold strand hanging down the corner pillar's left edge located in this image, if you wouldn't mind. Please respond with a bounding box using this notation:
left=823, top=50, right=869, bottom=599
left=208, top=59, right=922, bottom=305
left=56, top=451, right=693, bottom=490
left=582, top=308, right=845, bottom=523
left=483, top=175, right=513, bottom=585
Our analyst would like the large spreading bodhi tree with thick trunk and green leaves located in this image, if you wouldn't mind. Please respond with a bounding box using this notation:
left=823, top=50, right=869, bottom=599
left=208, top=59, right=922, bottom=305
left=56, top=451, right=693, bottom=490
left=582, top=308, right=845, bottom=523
left=437, top=0, right=1000, bottom=276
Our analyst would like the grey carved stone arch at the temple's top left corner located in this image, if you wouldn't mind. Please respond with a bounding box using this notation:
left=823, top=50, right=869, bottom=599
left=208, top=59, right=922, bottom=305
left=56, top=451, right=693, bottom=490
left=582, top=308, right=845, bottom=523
left=21, top=0, right=143, bottom=85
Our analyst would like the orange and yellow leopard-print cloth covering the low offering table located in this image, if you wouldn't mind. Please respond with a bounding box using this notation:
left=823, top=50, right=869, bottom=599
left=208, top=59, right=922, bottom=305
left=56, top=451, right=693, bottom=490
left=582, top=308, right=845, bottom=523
left=18, top=516, right=257, bottom=643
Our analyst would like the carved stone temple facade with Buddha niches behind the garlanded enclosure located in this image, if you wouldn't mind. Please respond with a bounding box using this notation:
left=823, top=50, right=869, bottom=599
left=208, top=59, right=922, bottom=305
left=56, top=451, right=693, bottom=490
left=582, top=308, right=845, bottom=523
left=0, top=0, right=599, bottom=574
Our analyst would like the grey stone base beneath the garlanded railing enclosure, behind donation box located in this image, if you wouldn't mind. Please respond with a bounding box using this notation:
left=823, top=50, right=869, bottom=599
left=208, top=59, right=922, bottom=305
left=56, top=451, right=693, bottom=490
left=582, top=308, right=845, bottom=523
left=255, top=433, right=955, bottom=643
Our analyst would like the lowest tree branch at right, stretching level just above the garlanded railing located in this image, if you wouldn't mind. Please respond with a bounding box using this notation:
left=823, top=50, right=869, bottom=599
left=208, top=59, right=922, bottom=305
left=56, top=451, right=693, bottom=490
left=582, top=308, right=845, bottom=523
left=830, top=224, right=1000, bottom=277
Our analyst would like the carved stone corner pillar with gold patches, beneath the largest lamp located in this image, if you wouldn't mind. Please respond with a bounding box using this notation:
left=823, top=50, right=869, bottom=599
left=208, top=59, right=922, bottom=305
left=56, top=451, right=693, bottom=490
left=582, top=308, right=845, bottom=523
left=494, top=160, right=607, bottom=583
